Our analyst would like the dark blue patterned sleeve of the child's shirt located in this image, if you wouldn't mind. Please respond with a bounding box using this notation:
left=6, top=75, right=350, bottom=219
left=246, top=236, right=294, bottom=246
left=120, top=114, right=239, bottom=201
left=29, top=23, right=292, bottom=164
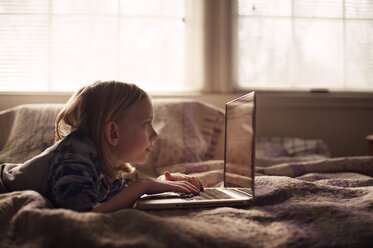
left=50, top=131, right=125, bottom=211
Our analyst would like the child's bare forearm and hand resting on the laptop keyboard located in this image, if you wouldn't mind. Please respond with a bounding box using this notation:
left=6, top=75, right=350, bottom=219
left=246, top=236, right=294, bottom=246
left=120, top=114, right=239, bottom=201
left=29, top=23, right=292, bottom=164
left=93, top=179, right=200, bottom=213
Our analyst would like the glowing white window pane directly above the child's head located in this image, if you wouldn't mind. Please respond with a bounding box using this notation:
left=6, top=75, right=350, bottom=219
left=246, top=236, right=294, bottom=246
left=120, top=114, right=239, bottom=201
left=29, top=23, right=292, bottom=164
left=51, top=16, right=118, bottom=91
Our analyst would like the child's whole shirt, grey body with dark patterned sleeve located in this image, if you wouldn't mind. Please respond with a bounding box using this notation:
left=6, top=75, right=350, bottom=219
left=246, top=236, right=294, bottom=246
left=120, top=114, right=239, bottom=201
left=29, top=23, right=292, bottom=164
left=1, top=131, right=126, bottom=211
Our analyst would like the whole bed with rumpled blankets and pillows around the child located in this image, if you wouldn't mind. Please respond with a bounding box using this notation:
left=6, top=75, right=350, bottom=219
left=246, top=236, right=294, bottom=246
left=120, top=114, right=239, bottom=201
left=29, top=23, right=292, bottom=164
left=0, top=99, right=373, bottom=248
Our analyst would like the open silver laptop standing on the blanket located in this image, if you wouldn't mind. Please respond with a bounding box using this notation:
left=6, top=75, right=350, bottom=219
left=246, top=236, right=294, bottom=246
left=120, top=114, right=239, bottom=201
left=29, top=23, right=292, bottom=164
left=136, top=92, right=256, bottom=210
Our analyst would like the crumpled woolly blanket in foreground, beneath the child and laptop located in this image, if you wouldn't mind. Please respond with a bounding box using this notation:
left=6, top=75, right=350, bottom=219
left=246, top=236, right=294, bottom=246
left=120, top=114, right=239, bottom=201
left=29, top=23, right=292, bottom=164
left=0, top=172, right=373, bottom=248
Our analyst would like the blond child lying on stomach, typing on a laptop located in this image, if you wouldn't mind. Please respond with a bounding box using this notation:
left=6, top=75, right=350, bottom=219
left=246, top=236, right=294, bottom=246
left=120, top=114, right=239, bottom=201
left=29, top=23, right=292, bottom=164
left=0, top=81, right=202, bottom=212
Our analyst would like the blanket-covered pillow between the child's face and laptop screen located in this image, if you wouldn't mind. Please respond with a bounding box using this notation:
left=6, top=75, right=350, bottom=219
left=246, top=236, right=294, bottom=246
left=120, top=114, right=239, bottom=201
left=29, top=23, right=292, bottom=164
left=134, top=99, right=224, bottom=177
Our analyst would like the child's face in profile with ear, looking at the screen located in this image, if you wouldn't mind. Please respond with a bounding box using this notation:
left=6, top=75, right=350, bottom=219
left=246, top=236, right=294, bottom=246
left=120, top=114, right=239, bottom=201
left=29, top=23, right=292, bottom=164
left=111, top=97, right=158, bottom=164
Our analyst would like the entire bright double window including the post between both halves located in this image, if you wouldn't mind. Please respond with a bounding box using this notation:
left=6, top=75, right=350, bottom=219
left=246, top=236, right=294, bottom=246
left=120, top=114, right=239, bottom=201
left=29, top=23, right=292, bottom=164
left=0, top=0, right=373, bottom=93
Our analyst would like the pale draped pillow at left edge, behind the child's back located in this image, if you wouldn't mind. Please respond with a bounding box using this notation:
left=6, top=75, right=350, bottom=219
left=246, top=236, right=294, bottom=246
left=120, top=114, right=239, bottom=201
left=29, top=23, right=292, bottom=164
left=0, top=104, right=63, bottom=163
